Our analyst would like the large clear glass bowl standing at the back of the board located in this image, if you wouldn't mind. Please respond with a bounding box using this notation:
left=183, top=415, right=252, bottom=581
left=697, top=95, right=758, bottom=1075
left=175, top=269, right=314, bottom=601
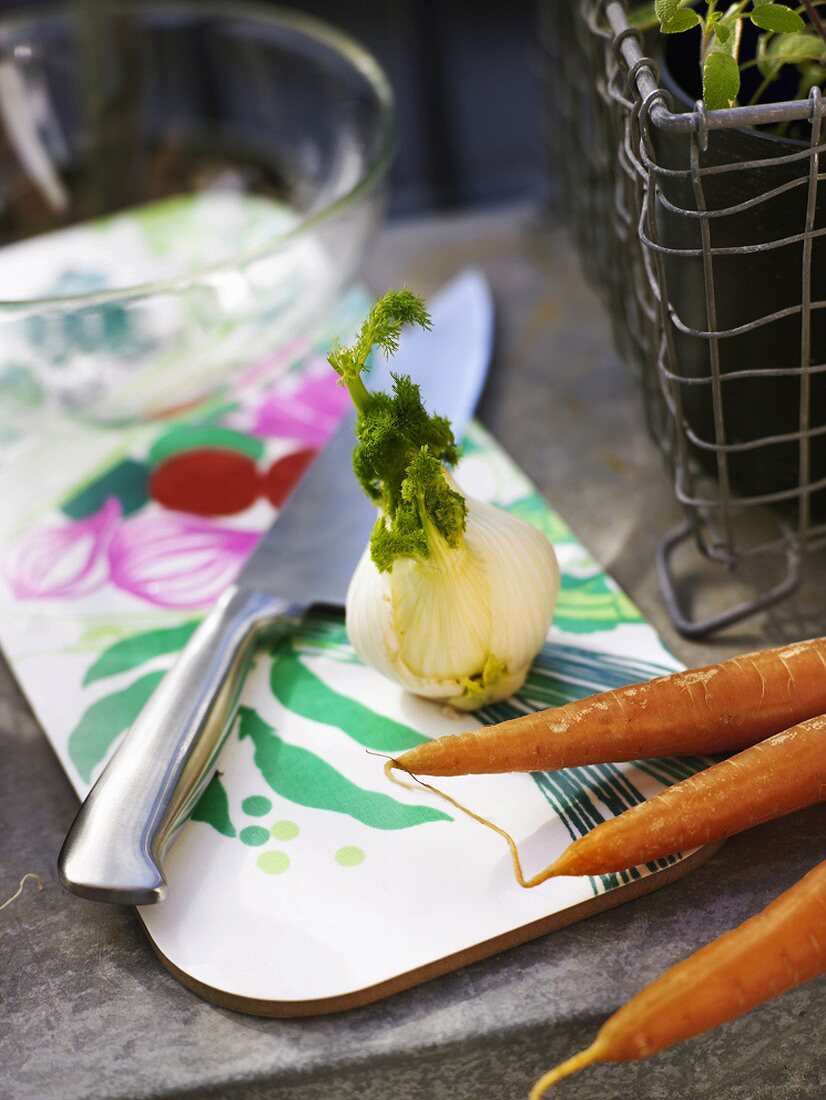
left=0, top=0, right=393, bottom=420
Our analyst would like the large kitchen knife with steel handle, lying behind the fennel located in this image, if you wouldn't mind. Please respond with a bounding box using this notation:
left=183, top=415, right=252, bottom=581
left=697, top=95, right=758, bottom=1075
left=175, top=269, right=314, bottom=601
left=57, top=271, right=493, bottom=905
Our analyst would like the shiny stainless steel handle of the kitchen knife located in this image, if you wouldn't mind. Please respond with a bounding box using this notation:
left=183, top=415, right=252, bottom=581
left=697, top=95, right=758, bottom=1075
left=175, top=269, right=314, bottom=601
left=57, top=587, right=304, bottom=905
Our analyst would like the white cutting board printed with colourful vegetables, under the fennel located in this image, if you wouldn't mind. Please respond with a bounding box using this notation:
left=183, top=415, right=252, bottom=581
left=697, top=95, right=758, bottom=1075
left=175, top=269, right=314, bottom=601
left=0, top=294, right=707, bottom=1015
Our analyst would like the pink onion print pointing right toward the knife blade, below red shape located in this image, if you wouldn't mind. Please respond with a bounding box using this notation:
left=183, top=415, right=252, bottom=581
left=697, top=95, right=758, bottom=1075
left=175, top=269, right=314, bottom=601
left=109, top=512, right=261, bottom=607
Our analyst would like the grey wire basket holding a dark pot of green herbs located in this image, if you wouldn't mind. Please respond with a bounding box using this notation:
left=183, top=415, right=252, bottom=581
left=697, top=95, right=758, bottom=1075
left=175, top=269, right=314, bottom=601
left=546, top=0, right=826, bottom=541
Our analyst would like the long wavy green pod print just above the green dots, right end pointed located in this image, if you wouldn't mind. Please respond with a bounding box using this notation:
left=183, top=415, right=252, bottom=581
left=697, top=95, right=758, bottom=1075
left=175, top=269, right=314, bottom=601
left=239, top=706, right=452, bottom=829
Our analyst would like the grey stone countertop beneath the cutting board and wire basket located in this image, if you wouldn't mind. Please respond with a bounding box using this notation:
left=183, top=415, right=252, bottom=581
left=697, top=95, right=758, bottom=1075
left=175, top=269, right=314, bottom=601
left=0, top=207, right=826, bottom=1100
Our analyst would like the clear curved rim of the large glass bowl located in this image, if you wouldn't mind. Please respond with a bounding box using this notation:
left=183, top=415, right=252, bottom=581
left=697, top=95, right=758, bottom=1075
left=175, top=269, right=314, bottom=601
left=0, top=0, right=395, bottom=312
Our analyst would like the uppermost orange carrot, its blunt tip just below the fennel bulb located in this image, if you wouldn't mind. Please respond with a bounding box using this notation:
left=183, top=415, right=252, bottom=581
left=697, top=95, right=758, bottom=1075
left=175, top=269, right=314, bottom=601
left=395, top=638, right=826, bottom=776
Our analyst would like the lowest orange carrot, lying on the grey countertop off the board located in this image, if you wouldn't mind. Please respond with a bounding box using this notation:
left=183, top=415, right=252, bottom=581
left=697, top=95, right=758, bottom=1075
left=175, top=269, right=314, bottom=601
left=530, top=861, right=826, bottom=1100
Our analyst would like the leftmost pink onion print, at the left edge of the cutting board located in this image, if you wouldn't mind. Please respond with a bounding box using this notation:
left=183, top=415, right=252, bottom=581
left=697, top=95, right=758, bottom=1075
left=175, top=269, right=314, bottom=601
left=3, top=497, right=121, bottom=600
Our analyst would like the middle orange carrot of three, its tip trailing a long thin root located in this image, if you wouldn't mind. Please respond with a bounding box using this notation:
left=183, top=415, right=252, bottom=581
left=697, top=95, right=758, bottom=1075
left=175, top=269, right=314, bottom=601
left=523, top=715, right=826, bottom=887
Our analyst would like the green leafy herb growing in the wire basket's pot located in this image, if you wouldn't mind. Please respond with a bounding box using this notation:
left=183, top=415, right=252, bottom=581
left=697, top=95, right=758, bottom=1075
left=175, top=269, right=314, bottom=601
left=632, top=0, right=826, bottom=110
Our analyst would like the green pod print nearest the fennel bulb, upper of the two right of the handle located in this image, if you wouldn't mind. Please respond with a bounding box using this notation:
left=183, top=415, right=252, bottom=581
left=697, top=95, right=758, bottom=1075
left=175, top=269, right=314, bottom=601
left=269, top=640, right=428, bottom=752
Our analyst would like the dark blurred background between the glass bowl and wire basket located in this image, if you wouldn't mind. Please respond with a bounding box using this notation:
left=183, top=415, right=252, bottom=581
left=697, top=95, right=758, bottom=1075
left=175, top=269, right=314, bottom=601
left=0, top=0, right=549, bottom=216
